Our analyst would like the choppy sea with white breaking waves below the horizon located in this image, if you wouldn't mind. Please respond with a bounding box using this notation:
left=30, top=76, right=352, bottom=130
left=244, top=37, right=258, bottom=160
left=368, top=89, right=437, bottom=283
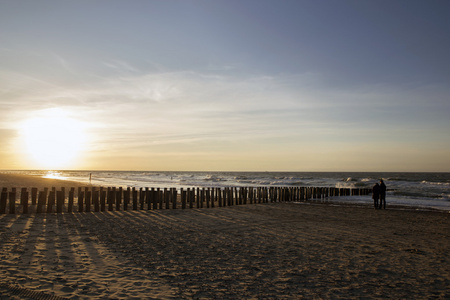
left=2, top=170, right=450, bottom=213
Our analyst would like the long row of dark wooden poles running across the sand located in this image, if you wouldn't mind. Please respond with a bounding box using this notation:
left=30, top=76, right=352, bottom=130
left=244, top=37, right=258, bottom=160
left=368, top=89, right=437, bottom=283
left=0, top=187, right=371, bottom=214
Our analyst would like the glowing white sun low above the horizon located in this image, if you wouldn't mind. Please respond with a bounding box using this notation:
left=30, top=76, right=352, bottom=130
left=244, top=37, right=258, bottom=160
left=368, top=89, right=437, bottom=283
left=21, top=109, right=85, bottom=169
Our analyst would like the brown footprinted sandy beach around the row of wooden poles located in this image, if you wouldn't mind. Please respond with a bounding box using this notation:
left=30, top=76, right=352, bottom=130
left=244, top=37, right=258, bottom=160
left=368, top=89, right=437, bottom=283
left=0, top=175, right=450, bottom=299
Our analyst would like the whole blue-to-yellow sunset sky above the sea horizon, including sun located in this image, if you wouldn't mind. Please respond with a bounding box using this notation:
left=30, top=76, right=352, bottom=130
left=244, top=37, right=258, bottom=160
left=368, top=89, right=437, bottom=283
left=0, top=0, right=450, bottom=172
